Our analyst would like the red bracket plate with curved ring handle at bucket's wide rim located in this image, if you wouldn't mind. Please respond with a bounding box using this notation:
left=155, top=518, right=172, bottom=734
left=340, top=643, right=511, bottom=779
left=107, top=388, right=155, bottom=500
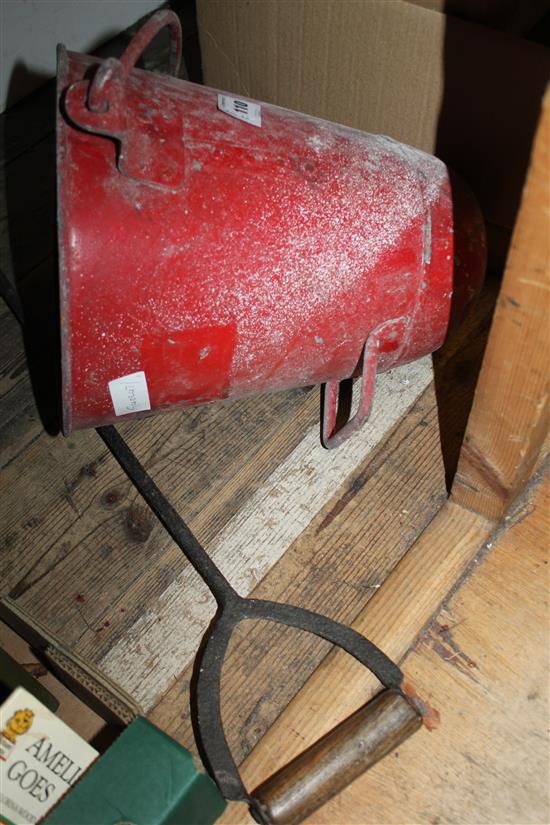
left=64, top=9, right=184, bottom=189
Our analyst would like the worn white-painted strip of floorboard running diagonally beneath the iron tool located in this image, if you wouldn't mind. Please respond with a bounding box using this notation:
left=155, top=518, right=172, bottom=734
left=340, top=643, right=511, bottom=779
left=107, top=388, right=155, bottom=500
left=100, top=356, right=433, bottom=709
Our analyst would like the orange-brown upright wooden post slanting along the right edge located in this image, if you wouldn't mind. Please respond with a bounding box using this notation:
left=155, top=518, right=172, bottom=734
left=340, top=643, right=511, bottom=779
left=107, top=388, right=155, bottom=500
left=453, top=88, right=550, bottom=518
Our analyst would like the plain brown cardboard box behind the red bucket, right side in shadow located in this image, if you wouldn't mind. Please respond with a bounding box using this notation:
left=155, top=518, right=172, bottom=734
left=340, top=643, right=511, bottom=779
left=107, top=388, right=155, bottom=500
left=197, top=0, right=550, bottom=261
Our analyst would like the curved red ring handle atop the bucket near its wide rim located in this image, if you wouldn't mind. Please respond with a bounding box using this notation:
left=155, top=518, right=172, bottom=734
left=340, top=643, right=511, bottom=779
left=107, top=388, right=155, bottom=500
left=87, top=9, right=182, bottom=112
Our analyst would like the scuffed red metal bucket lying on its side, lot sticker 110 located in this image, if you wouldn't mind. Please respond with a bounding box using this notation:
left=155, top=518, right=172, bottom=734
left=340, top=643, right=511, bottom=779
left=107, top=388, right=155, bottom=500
left=58, top=11, right=484, bottom=446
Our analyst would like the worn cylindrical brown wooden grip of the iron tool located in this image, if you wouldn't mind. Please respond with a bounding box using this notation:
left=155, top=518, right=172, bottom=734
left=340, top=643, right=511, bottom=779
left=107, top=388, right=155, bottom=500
left=252, top=690, right=422, bottom=825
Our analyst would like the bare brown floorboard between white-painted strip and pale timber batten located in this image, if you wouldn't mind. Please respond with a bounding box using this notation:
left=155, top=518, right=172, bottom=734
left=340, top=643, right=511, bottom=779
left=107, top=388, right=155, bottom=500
left=151, top=376, right=446, bottom=744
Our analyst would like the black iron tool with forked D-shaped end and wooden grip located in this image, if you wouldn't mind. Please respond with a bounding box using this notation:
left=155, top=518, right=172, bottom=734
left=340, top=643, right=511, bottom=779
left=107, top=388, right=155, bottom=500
left=97, top=426, right=422, bottom=825
